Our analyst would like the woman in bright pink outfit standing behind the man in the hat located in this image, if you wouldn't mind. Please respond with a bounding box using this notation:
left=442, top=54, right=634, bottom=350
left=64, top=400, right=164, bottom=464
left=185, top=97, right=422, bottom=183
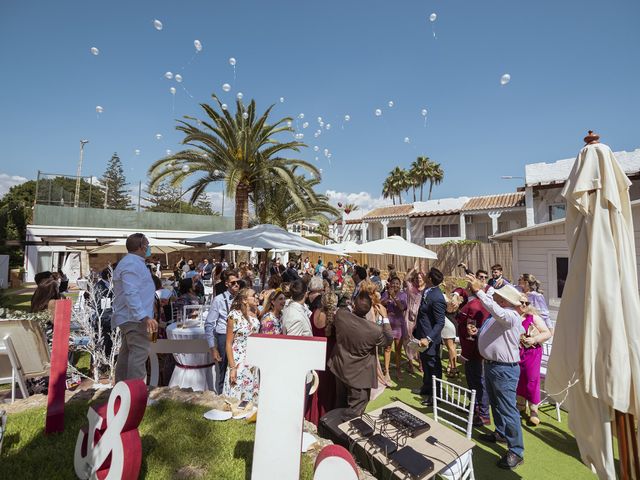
left=516, top=302, right=551, bottom=426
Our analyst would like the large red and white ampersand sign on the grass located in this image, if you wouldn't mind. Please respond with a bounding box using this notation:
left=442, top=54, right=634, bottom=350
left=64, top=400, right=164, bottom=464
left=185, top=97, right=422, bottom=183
left=73, top=380, right=147, bottom=480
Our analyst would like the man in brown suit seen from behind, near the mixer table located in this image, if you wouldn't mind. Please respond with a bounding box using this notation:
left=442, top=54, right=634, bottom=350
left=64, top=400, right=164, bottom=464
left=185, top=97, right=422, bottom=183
left=329, top=292, right=393, bottom=419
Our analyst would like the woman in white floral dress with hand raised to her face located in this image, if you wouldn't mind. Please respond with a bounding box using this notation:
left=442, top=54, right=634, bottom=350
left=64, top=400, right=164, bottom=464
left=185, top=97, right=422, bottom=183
left=222, top=288, right=260, bottom=404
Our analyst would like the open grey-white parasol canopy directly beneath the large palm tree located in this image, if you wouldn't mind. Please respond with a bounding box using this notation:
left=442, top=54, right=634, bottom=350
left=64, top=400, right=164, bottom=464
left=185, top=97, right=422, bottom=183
left=188, top=224, right=342, bottom=255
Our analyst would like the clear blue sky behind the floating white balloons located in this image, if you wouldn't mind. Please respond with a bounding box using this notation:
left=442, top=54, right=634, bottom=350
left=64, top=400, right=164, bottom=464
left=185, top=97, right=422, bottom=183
left=0, top=0, right=640, bottom=210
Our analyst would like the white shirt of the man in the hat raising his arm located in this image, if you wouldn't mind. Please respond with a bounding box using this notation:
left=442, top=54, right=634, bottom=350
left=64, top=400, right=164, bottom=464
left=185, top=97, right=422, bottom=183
left=476, top=290, right=524, bottom=363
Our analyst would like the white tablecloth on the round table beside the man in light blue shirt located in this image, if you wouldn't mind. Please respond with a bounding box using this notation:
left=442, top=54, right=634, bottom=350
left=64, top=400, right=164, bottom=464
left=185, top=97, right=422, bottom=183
left=167, top=323, right=216, bottom=391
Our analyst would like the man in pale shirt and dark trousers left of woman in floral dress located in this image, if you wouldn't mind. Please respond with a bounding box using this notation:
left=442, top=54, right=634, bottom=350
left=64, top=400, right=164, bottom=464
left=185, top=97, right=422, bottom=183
left=204, top=271, right=240, bottom=395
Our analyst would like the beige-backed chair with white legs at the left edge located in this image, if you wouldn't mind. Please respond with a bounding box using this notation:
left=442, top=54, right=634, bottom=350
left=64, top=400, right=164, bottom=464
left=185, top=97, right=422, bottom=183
left=0, top=320, right=50, bottom=402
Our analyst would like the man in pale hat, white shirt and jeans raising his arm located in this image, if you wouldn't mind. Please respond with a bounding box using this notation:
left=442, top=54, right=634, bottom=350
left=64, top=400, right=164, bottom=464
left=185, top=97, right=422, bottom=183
left=467, top=274, right=524, bottom=469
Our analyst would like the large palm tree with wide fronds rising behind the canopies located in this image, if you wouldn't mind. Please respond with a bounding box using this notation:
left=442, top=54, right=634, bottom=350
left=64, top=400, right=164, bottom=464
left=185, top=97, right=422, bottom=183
left=149, top=95, right=320, bottom=229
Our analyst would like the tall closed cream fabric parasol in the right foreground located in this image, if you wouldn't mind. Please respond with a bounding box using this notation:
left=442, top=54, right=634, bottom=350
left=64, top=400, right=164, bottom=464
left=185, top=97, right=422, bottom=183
left=545, top=132, right=640, bottom=478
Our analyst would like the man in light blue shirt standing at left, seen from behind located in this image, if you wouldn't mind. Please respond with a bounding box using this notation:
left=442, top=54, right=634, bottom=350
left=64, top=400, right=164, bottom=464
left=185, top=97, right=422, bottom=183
left=111, top=233, right=158, bottom=382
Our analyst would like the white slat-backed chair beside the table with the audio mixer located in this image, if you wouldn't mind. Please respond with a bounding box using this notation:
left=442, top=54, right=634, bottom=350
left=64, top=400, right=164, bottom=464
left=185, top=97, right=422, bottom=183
left=431, top=375, right=476, bottom=480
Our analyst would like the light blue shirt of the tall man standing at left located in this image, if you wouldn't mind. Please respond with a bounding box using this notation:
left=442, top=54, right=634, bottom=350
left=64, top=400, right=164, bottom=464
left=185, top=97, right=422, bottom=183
left=111, top=253, right=156, bottom=326
